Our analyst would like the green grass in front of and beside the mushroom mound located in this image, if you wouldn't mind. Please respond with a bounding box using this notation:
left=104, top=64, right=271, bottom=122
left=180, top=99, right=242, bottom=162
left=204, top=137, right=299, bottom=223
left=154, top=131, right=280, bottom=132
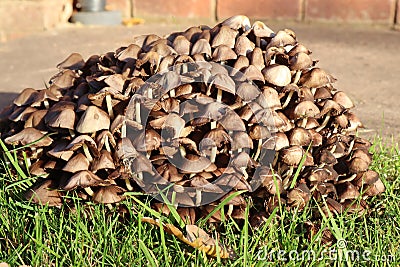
left=0, top=138, right=400, bottom=266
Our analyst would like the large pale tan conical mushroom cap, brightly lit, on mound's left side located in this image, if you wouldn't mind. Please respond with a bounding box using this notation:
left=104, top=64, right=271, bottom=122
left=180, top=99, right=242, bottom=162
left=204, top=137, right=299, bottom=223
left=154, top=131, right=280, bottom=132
left=76, top=106, right=110, bottom=133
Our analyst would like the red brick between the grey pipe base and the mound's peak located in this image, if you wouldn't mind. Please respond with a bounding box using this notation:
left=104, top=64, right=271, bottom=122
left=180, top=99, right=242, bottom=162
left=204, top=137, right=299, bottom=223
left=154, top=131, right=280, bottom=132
left=135, top=0, right=213, bottom=18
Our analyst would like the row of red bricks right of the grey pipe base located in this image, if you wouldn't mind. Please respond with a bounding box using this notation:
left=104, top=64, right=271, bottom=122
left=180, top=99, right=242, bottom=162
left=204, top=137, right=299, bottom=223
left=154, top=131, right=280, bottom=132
left=112, top=0, right=400, bottom=27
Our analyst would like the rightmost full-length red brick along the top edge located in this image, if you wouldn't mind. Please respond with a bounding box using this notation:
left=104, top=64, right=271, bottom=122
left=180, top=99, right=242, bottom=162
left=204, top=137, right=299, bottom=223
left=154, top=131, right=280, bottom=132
left=305, top=0, right=394, bottom=23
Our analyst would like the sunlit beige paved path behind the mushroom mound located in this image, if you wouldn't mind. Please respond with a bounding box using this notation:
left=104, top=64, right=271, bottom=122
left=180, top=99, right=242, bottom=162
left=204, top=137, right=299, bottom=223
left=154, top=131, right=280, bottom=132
left=0, top=22, right=400, bottom=140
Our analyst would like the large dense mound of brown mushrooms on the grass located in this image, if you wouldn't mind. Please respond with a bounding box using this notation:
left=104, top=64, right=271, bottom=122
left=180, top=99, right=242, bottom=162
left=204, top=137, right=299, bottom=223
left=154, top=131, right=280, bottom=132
left=0, top=16, right=385, bottom=222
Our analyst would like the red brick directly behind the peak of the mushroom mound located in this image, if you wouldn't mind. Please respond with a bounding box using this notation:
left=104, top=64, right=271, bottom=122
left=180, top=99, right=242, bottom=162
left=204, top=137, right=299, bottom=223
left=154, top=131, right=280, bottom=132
left=217, top=0, right=301, bottom=19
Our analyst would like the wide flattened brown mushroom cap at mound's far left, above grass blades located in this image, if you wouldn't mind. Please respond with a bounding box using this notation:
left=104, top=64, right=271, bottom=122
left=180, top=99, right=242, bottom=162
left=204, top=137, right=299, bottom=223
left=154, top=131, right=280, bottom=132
left=4, top=128, right=53, bottom=147
